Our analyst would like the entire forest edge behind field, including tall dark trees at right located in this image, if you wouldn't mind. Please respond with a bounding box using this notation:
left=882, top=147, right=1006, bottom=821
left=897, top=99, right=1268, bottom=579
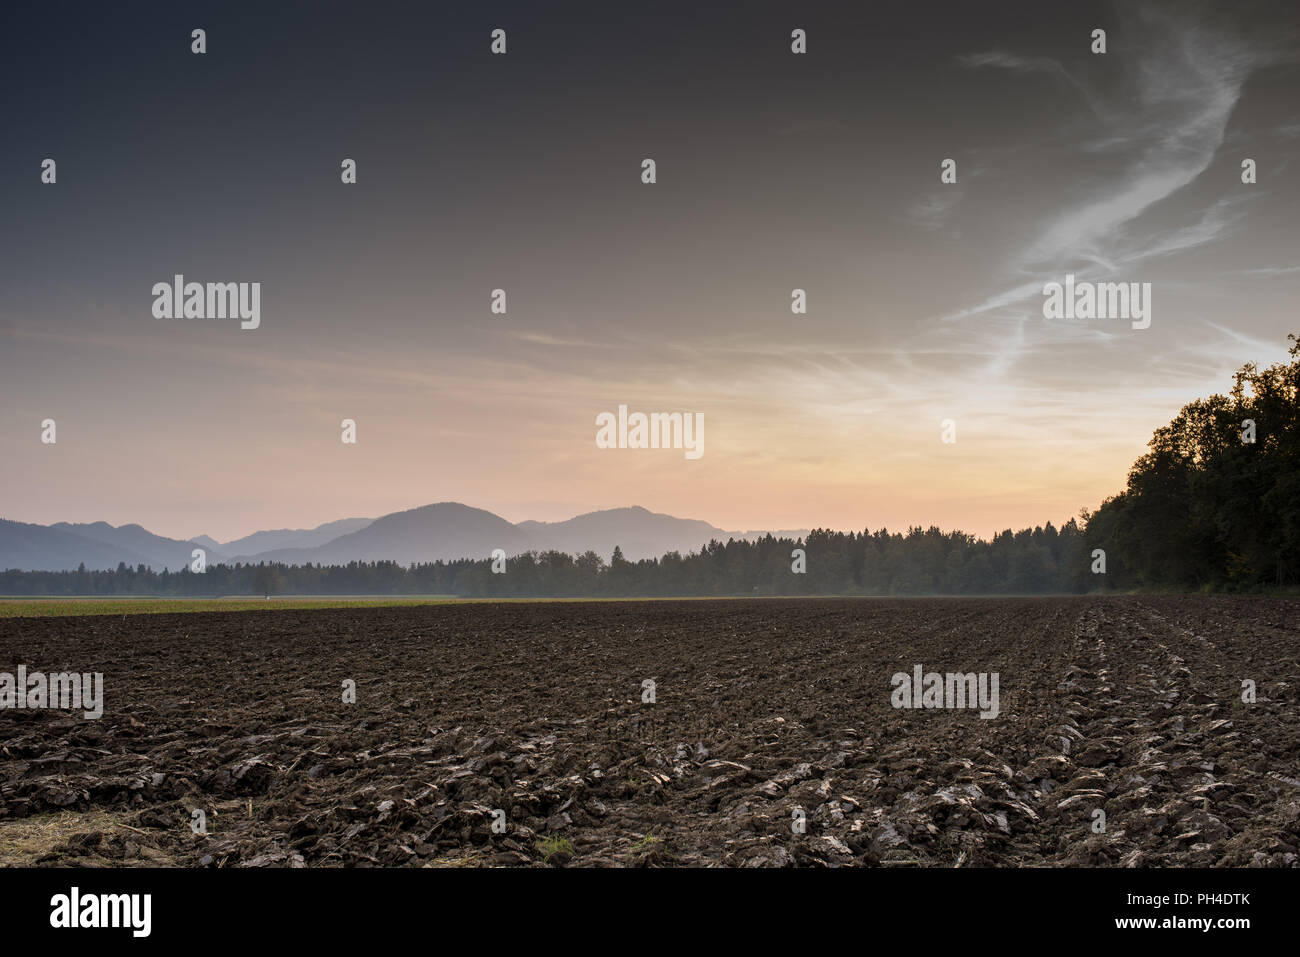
left=0, top=335, right=1300, bottom=597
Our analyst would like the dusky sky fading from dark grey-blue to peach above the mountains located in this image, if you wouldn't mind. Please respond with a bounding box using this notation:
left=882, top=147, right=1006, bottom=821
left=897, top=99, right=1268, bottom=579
left=0, top=0, right=1300, bottom=541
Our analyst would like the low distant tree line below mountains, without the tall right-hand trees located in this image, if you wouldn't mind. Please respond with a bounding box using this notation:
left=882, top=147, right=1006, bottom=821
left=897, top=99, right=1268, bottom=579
left=0, top=519, right=1093, bottom=598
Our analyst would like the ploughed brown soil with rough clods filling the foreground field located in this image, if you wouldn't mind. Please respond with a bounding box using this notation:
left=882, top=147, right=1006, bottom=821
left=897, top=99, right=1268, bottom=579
left=0, top=598, right=1300, bottom=867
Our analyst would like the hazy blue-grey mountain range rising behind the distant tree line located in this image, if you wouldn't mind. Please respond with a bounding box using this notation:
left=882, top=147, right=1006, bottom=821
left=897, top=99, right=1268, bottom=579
left=0, top=502, right=807, bottom=571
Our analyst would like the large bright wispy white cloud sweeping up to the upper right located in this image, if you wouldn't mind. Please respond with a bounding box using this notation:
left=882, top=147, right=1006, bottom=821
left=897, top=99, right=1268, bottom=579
left=944, top=8, right=1271, bottom=328
